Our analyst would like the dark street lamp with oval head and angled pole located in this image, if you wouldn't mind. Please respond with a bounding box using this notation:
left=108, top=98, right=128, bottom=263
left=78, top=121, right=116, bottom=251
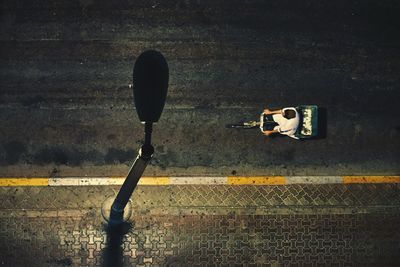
left=108, top=50, right=169, bottom=225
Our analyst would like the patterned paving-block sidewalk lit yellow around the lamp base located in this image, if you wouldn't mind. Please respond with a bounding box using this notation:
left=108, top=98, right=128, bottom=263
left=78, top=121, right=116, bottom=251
left=0, top=184, right=400, bottom=266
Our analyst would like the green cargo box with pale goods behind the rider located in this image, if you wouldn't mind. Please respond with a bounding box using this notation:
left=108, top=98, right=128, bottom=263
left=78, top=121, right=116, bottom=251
left=295, top=105, right=318, bottom=138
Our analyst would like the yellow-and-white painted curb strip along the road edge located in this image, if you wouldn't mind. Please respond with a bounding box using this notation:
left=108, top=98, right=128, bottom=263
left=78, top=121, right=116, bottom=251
left=0, top=176, right=400, bottom=186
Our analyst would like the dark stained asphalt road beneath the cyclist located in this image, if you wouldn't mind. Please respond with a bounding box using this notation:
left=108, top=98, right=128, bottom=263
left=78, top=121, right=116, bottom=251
left=0, top=0, right=400, bottom=177
